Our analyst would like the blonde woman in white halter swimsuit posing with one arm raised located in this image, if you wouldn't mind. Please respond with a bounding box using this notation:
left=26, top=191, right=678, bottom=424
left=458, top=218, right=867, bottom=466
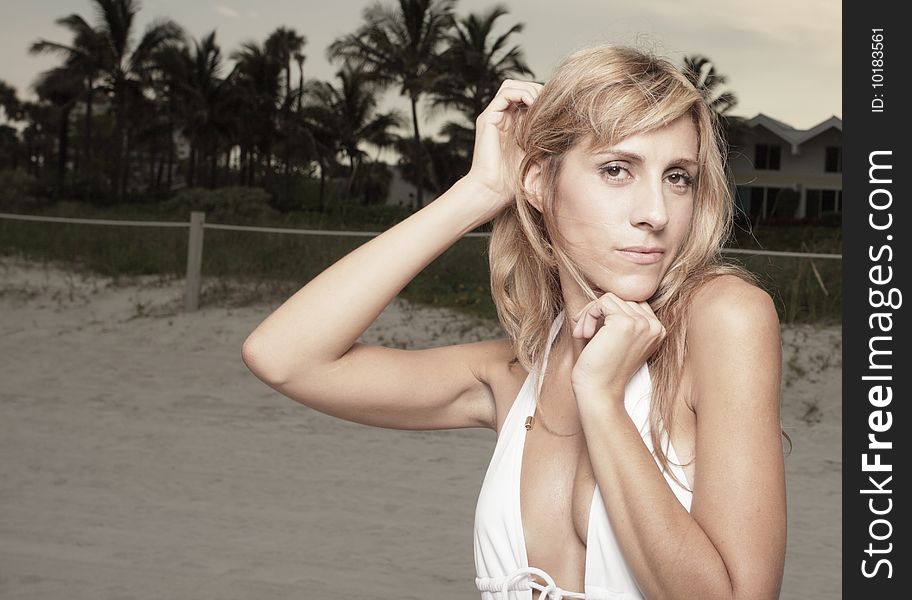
left=243, top=45, right=786, bottom=600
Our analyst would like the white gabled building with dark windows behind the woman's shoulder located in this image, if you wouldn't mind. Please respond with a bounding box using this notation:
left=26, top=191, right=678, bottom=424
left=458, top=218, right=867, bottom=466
left=729, top=113, right=842, bottom=223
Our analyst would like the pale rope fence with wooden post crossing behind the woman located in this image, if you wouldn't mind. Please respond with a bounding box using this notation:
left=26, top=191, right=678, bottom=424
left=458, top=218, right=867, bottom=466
left=0, top=211, right=842, bottom=312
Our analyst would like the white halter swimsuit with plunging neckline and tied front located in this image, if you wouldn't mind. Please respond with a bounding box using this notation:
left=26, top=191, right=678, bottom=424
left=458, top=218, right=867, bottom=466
left=474, top=311, right=691, bottom=600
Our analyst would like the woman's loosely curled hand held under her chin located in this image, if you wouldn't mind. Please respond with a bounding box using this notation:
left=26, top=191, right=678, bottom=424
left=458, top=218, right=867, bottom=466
left=570, top=292, right=665, bottom=398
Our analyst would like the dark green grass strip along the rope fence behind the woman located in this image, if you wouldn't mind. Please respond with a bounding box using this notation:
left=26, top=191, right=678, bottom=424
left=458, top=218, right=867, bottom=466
left=0, top=203, right=842, bottom=324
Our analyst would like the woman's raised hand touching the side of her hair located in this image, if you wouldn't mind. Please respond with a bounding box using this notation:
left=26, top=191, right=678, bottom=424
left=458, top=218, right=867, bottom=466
left=465, top=79, right=543, bottom=212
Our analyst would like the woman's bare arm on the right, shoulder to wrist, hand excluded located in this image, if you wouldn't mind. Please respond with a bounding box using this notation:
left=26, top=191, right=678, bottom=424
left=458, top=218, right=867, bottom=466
left=574, top=278, right=786, bottom=600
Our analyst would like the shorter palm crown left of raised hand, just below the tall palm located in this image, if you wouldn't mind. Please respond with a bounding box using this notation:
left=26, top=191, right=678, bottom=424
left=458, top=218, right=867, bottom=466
left=309, top=61, right=404, bottom=202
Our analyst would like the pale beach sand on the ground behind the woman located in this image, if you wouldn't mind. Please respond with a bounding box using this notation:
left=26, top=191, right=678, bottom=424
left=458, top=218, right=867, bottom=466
left=0, top=257, right=842, bottom=600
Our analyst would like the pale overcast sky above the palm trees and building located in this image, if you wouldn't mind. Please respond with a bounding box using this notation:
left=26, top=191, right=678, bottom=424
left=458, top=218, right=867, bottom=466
left=0, top=0, right=842, bottom=133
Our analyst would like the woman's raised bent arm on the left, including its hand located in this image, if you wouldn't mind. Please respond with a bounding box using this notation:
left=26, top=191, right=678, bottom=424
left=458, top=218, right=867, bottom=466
left=242, top=80, right=541, bottom=429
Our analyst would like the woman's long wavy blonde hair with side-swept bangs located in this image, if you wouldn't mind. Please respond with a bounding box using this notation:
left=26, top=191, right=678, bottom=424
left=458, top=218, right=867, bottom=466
left=488, top=44, right=757, bottom=486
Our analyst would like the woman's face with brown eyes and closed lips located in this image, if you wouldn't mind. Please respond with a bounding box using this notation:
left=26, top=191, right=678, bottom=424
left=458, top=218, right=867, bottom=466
left=555, top=115, right=698, bottom=302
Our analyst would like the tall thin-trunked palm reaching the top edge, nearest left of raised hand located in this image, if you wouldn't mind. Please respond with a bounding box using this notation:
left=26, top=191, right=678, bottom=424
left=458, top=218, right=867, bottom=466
left=327, top=0, right=455, bottom=208
